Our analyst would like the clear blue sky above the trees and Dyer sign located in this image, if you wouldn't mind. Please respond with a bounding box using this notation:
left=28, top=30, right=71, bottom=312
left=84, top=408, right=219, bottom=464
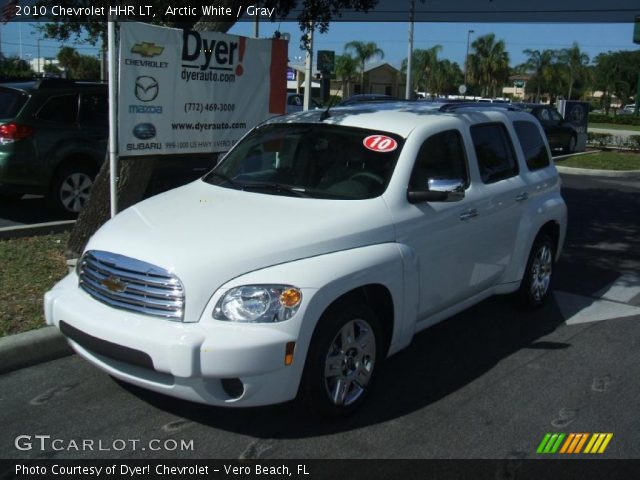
left=0, top=22, right=640, bottom=68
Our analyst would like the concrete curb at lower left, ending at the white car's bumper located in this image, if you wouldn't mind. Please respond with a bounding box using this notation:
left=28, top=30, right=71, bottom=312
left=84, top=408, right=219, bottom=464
left=0, top=327, right=73, bottom=374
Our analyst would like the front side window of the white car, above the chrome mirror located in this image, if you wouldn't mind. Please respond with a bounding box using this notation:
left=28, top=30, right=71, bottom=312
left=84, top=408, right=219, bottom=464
left=409, top=130, right=468, bottom=190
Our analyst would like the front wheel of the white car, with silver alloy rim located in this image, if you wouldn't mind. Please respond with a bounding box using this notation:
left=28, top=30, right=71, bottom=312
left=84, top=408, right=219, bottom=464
left=302, top=301, right=385, bottom=417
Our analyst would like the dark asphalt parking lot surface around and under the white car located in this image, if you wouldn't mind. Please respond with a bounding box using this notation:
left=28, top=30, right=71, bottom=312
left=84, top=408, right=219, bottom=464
left=0, top=175, right=640, bottom=459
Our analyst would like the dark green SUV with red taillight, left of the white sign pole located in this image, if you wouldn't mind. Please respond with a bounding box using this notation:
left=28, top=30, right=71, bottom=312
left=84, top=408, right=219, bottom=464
left=0, top=79, right=109, bottom=215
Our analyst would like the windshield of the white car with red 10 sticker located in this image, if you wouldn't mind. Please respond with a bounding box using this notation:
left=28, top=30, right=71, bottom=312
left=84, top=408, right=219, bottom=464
left=204, top=124, right=403, bottom=200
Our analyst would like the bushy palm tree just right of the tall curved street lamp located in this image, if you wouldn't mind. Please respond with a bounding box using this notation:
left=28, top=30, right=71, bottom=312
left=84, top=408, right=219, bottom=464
left=468, top=33, right=509, bottom=96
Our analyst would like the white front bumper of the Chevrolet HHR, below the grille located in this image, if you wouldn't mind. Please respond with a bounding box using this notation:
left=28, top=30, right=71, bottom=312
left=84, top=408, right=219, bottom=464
left=45, top=274, right=306, bottom=407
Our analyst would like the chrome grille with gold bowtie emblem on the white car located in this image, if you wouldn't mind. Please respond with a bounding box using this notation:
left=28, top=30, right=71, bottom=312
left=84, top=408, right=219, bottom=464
left=77, top=250, right=184, bottom=321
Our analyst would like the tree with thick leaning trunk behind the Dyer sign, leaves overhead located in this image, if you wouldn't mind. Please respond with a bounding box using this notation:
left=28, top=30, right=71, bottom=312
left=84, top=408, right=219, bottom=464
left=42, top=0, right=376, bottom=256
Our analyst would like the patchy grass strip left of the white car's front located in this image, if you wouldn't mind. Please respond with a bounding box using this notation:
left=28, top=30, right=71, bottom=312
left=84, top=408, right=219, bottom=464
left=0, top=233, right=69, bottom=337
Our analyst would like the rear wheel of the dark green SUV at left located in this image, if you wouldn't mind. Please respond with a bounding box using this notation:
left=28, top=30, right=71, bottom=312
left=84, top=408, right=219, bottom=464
left=49, top=163, right=96, bottom=216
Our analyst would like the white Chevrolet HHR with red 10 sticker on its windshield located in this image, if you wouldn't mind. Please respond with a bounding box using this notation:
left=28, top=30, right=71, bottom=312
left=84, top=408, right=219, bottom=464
left=45, top=103, right=567, bottom=415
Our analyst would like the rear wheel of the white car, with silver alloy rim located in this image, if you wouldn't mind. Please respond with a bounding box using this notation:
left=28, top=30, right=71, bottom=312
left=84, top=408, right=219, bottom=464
left=516, top=232, right=555, bottom=309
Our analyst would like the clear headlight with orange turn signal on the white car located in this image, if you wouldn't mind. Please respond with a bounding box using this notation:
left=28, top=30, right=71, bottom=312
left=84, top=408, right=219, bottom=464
left=213, top=285, right=302, bottom=323
